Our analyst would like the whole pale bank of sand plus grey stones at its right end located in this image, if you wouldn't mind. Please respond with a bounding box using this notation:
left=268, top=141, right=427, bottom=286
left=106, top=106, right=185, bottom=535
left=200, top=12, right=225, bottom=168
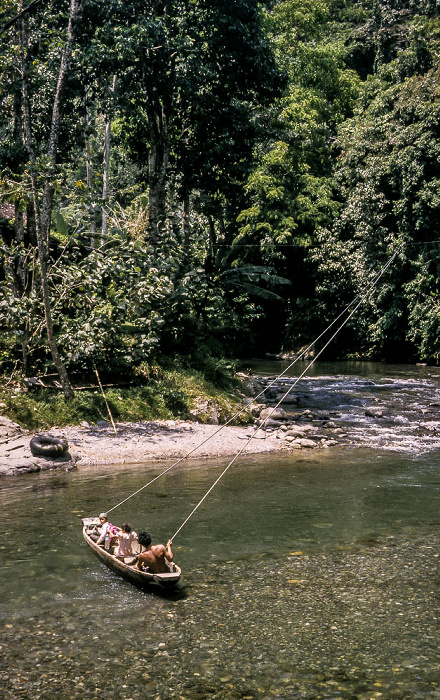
left=0, top=409, right=346, bottom=476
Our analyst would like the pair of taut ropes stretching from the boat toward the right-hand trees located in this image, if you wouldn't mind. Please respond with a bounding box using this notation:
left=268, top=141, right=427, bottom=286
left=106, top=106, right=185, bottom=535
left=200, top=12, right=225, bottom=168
left=107, top=243, right=405, bottom=524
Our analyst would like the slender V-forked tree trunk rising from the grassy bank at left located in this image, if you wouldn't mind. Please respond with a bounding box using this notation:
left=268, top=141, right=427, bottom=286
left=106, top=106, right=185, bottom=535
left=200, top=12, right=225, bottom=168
left=20, top=0, right=79, bottom=399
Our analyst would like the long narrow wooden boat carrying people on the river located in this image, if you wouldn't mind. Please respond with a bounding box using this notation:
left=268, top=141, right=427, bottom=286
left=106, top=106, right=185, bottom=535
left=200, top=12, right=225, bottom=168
left=82, top=518, right=182, bottom=588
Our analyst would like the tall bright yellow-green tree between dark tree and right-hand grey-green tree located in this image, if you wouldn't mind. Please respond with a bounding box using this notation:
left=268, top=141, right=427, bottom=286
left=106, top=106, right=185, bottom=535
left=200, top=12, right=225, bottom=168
left=230, top=0, right=360, bottom=351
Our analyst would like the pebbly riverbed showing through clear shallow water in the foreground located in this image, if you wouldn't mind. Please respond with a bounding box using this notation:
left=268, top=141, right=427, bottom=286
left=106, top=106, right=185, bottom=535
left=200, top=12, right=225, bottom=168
left=0, top=535, right=440, bottom=700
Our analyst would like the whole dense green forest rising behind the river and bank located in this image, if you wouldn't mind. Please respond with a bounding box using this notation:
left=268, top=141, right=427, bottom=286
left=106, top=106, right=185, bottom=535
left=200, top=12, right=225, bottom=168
left=0, top=0, right=440, bottom=400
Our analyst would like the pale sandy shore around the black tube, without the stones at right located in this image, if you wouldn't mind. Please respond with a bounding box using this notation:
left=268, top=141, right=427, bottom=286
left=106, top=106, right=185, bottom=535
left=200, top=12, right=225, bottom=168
left=0, top=419, right=287, bottom=476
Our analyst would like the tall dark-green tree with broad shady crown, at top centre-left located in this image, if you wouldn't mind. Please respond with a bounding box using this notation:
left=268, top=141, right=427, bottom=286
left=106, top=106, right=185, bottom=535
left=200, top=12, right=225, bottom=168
left=93, top=0, right=281, bottom=239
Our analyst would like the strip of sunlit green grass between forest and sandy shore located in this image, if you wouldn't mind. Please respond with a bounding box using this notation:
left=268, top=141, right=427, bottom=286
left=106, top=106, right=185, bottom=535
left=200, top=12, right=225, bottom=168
left=0, top=370, right=252, bottom=430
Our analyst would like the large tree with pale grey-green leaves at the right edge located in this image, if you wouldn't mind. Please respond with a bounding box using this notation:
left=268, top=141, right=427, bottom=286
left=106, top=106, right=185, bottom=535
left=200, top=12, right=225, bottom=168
left=313, top=4, right=440, bottom=361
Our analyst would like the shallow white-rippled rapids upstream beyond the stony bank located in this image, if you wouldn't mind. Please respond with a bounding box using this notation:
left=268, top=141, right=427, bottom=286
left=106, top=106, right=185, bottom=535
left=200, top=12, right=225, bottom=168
left=251, top=362, right=440, bottom=454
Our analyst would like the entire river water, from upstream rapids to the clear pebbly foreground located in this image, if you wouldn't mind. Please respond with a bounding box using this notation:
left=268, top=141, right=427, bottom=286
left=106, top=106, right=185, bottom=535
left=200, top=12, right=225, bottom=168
left=0, top=363, right=440, bottom=700
